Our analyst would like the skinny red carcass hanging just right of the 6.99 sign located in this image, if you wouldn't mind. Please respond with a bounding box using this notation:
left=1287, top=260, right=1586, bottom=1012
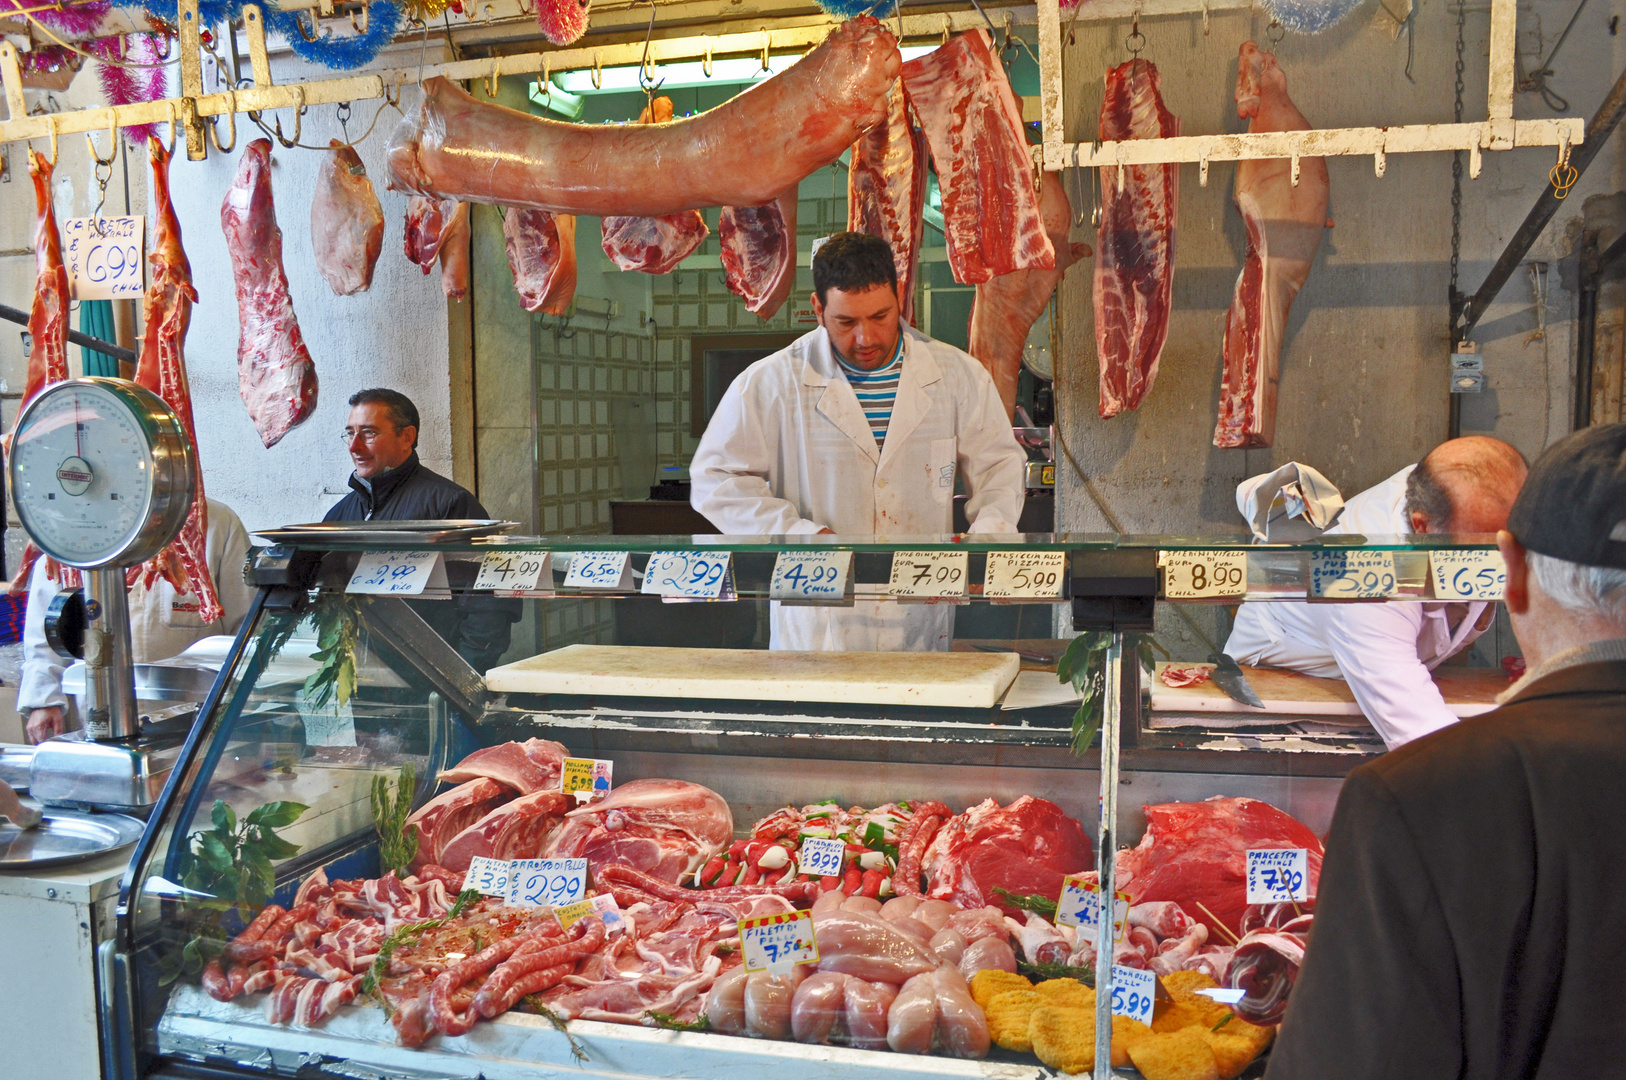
left=127, top=137, right=226, bottom=623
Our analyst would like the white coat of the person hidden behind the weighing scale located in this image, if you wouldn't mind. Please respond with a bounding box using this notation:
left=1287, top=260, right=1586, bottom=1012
left=16, top=499, right=254, bottom=716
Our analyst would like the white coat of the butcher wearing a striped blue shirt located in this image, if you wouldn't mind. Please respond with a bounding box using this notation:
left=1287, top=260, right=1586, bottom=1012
left=689, top=327, right=1026, bottom=651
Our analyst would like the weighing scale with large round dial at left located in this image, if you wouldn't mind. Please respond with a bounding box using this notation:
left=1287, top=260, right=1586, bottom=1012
left=8, top=377, right=197, bottom=812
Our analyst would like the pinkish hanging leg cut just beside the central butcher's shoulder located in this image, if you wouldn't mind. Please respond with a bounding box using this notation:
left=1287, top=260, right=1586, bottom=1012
left=966, top=172, right=1089, bottom=421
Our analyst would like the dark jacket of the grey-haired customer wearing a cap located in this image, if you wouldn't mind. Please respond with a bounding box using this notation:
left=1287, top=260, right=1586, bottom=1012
left=1265, top=662, right=1626, bottom=1080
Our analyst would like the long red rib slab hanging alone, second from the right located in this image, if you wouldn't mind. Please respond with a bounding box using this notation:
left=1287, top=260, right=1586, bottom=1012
left=1094, top=57, right=1180, bottom=416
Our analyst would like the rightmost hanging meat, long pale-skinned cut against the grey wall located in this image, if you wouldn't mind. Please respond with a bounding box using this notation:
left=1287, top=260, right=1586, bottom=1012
left=1215, top=41, right=1328, bottom=447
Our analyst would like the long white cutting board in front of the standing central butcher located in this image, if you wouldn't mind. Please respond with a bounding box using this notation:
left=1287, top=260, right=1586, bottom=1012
left=486, top=646, right=1021, bottom=709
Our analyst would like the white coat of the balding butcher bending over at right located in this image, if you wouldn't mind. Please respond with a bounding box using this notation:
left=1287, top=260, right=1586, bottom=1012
left=1224, top=465, right=1489, bottom=750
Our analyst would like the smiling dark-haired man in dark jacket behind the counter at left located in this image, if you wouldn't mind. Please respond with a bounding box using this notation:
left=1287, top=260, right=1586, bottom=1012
left=322, top=389, right=520, bottom=675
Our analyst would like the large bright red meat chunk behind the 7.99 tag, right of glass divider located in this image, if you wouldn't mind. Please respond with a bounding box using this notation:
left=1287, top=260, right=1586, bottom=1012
left=1117, top=795, right=1322, bottom=940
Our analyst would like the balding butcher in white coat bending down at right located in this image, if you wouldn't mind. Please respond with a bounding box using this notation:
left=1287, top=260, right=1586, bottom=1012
left=1224, top=436, right=1527, bottom=750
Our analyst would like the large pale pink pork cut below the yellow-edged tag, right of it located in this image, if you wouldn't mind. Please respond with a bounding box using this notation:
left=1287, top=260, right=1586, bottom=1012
left=548, top=781, right=733, bottom=882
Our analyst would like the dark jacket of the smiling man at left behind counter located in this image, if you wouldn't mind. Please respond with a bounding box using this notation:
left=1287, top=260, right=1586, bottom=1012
left=322, top=452, right=520, bottom=675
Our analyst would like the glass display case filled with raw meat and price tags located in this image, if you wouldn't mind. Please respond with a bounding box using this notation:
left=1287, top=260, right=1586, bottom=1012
left=102, top=535, right=1506, bottom=1080
